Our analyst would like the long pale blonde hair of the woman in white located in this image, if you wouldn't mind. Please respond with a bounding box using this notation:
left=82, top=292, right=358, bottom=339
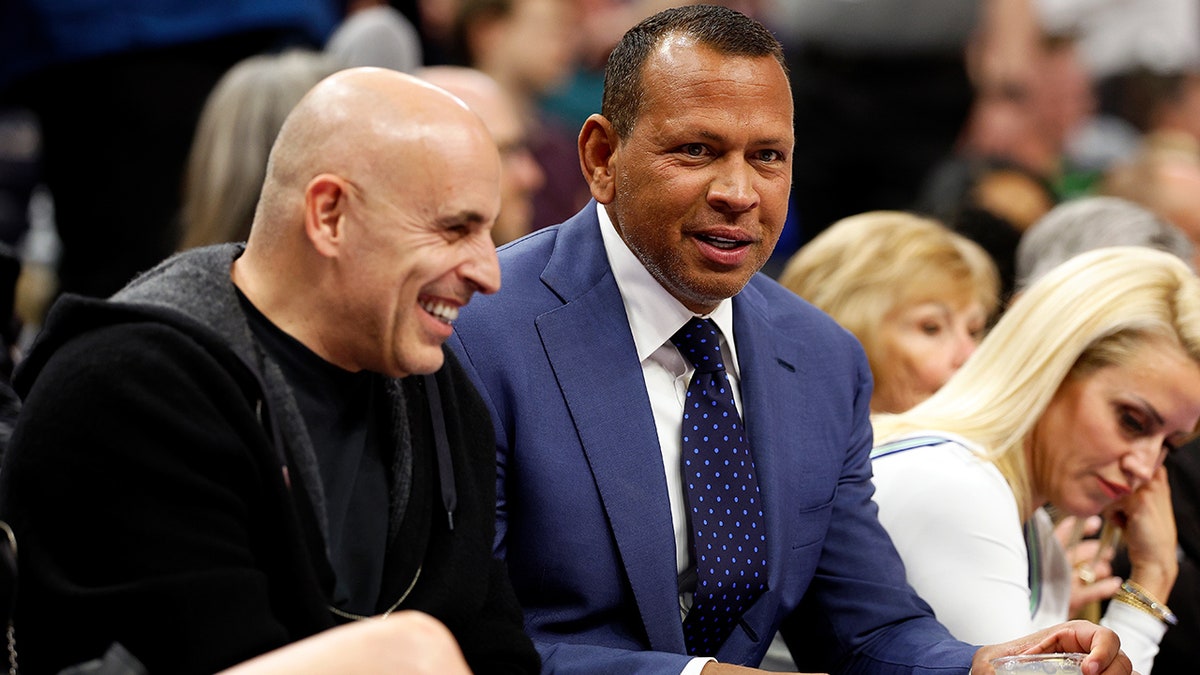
left=872, top=246, right=1200, bottom=516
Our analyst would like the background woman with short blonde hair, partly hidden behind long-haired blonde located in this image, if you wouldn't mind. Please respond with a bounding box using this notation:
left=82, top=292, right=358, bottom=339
left=780, top=211, right=1000, bottom=412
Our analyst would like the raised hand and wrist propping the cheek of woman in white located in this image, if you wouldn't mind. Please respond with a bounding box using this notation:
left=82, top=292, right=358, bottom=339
left=1108, top=466, right=1180, bottom=602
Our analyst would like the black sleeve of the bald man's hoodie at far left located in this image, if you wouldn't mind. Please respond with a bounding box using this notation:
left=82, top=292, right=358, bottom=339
left=0, top=324, right=304, bottom=674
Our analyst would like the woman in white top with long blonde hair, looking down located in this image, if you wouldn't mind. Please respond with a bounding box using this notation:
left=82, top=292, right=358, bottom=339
left=872, top=247, right=1200, bottom=674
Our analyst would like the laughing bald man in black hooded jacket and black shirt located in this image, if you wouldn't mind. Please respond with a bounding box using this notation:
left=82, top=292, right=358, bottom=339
left=0, top=68, right=539, bottom=674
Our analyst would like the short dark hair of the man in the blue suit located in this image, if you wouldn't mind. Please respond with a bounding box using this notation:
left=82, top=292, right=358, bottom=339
left=600, top=5, right=787, bottom=138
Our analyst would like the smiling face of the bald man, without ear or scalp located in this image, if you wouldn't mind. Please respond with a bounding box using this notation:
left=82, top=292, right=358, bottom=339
left=337, top=129, right=500, bottom=377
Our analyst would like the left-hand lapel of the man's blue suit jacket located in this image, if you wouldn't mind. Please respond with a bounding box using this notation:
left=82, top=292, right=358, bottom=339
left=536, top=207, right=683, bottom=651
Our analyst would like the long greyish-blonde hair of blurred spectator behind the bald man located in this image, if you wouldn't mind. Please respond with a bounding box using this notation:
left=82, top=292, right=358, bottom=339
left=179, top=49, right=336, bottom=250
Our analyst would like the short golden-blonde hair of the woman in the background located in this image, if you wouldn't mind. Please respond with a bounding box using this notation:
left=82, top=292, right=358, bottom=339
left=779, top=211, right=1000, bottom=378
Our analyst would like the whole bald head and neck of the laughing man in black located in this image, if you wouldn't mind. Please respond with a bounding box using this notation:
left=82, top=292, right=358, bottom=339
left=230, top=67, right=500, bottom=377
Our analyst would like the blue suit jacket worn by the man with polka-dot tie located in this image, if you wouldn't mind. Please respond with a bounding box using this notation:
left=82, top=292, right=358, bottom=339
left=451, top=203, right=974, bottom=674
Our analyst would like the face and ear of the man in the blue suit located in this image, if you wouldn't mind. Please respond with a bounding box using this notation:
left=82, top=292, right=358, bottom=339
left=592, top=36, right=793, bottom=313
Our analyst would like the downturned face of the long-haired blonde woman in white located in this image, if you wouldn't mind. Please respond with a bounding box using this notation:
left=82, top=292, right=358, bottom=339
left=1027, top=339, right=1200, bottom=516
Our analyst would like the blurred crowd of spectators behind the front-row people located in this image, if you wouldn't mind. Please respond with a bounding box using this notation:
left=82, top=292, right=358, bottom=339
left=0, top=0, right=1200, bottom=673
